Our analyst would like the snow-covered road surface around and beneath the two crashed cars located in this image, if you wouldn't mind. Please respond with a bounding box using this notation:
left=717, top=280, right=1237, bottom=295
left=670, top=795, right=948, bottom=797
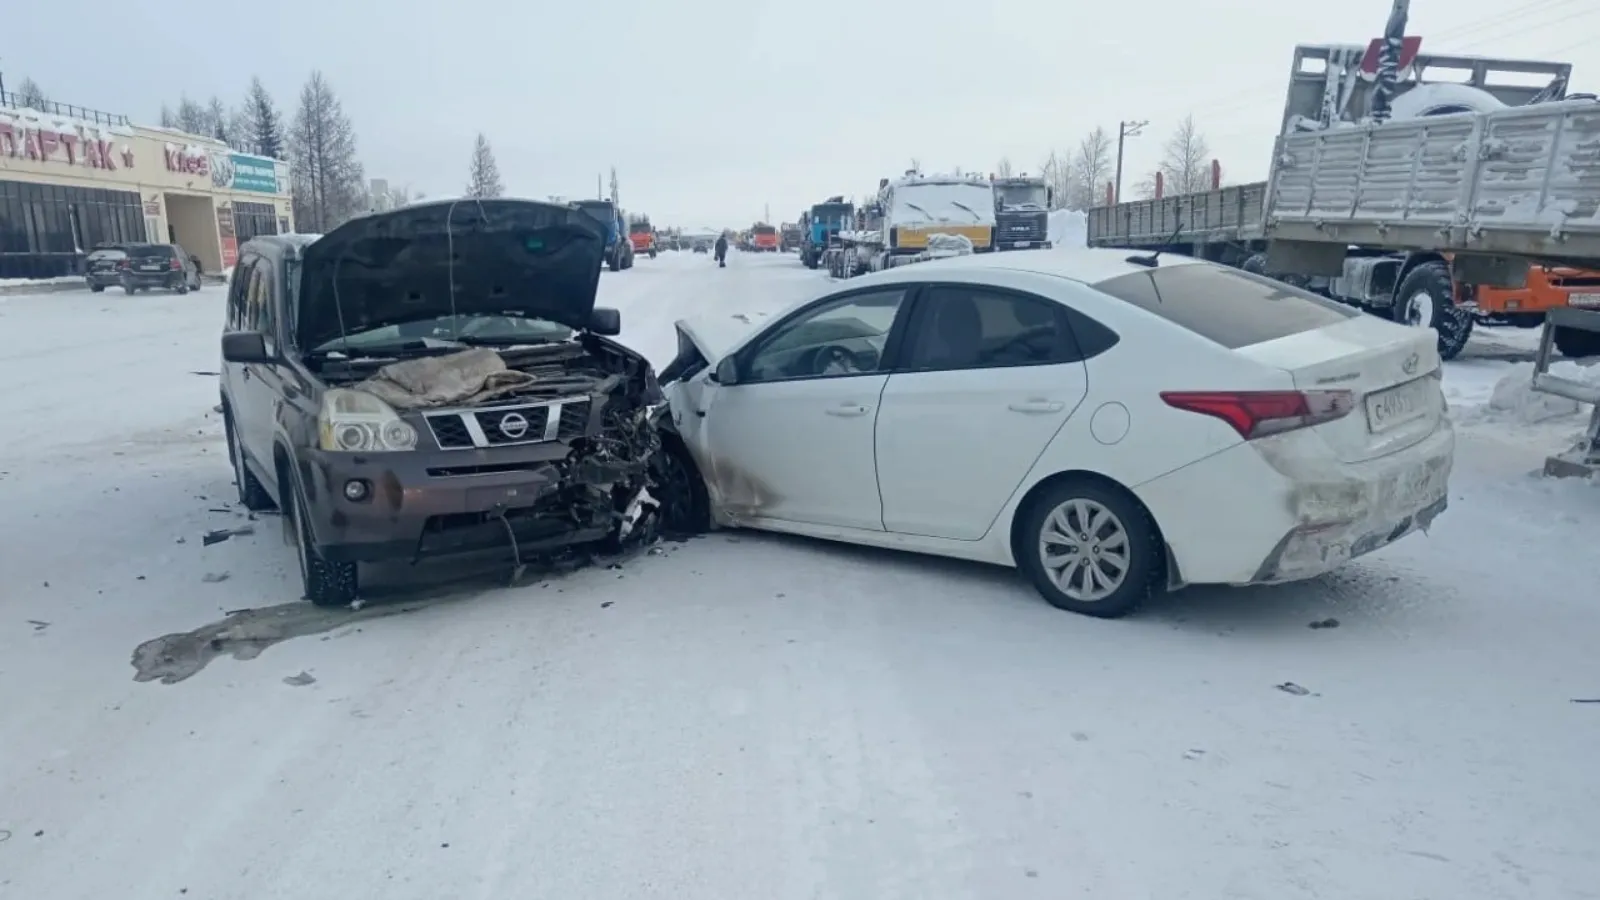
left=0, top=253, right=1600, bottom=900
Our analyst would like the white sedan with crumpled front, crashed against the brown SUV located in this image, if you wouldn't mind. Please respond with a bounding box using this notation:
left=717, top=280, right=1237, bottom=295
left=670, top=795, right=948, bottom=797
left=646, top=250, right=1454, bottom=617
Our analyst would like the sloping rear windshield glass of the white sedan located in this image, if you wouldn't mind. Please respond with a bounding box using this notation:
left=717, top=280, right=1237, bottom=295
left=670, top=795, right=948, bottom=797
left=1094, top=264, right=1362, bottom=349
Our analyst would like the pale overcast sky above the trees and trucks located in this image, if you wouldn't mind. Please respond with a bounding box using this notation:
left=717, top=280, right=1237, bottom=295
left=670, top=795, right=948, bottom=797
left=0, top=0, right=1600, bottom=226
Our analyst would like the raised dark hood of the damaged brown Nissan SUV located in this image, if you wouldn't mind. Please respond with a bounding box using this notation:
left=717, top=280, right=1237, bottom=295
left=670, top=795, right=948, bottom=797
left=296, top=200, right=605, bottom=351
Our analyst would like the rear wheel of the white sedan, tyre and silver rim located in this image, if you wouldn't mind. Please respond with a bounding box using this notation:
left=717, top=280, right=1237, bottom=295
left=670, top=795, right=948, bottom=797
left=1014, top=480, right=1165, bottom=618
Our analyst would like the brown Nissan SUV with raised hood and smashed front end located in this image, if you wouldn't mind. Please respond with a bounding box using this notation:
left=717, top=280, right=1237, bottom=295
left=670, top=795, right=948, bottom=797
left=221, top=200, right=688, bottom=605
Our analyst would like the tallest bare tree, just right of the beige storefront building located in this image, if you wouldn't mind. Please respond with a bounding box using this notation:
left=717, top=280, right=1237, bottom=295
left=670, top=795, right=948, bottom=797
left=290, top=72, right=368, bottom=234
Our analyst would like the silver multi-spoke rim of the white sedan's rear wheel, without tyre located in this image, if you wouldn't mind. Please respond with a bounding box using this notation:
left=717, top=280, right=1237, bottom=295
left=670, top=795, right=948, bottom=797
left=1038, top=498, right=1133, bottom=604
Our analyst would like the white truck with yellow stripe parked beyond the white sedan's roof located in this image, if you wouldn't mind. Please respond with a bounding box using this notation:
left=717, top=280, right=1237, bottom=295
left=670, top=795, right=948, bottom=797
left=822, top=171, right=995, bottom=279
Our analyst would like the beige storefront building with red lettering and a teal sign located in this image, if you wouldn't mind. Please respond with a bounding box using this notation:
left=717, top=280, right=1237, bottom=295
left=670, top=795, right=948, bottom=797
left=0, top=96, right=294, bottom=279
